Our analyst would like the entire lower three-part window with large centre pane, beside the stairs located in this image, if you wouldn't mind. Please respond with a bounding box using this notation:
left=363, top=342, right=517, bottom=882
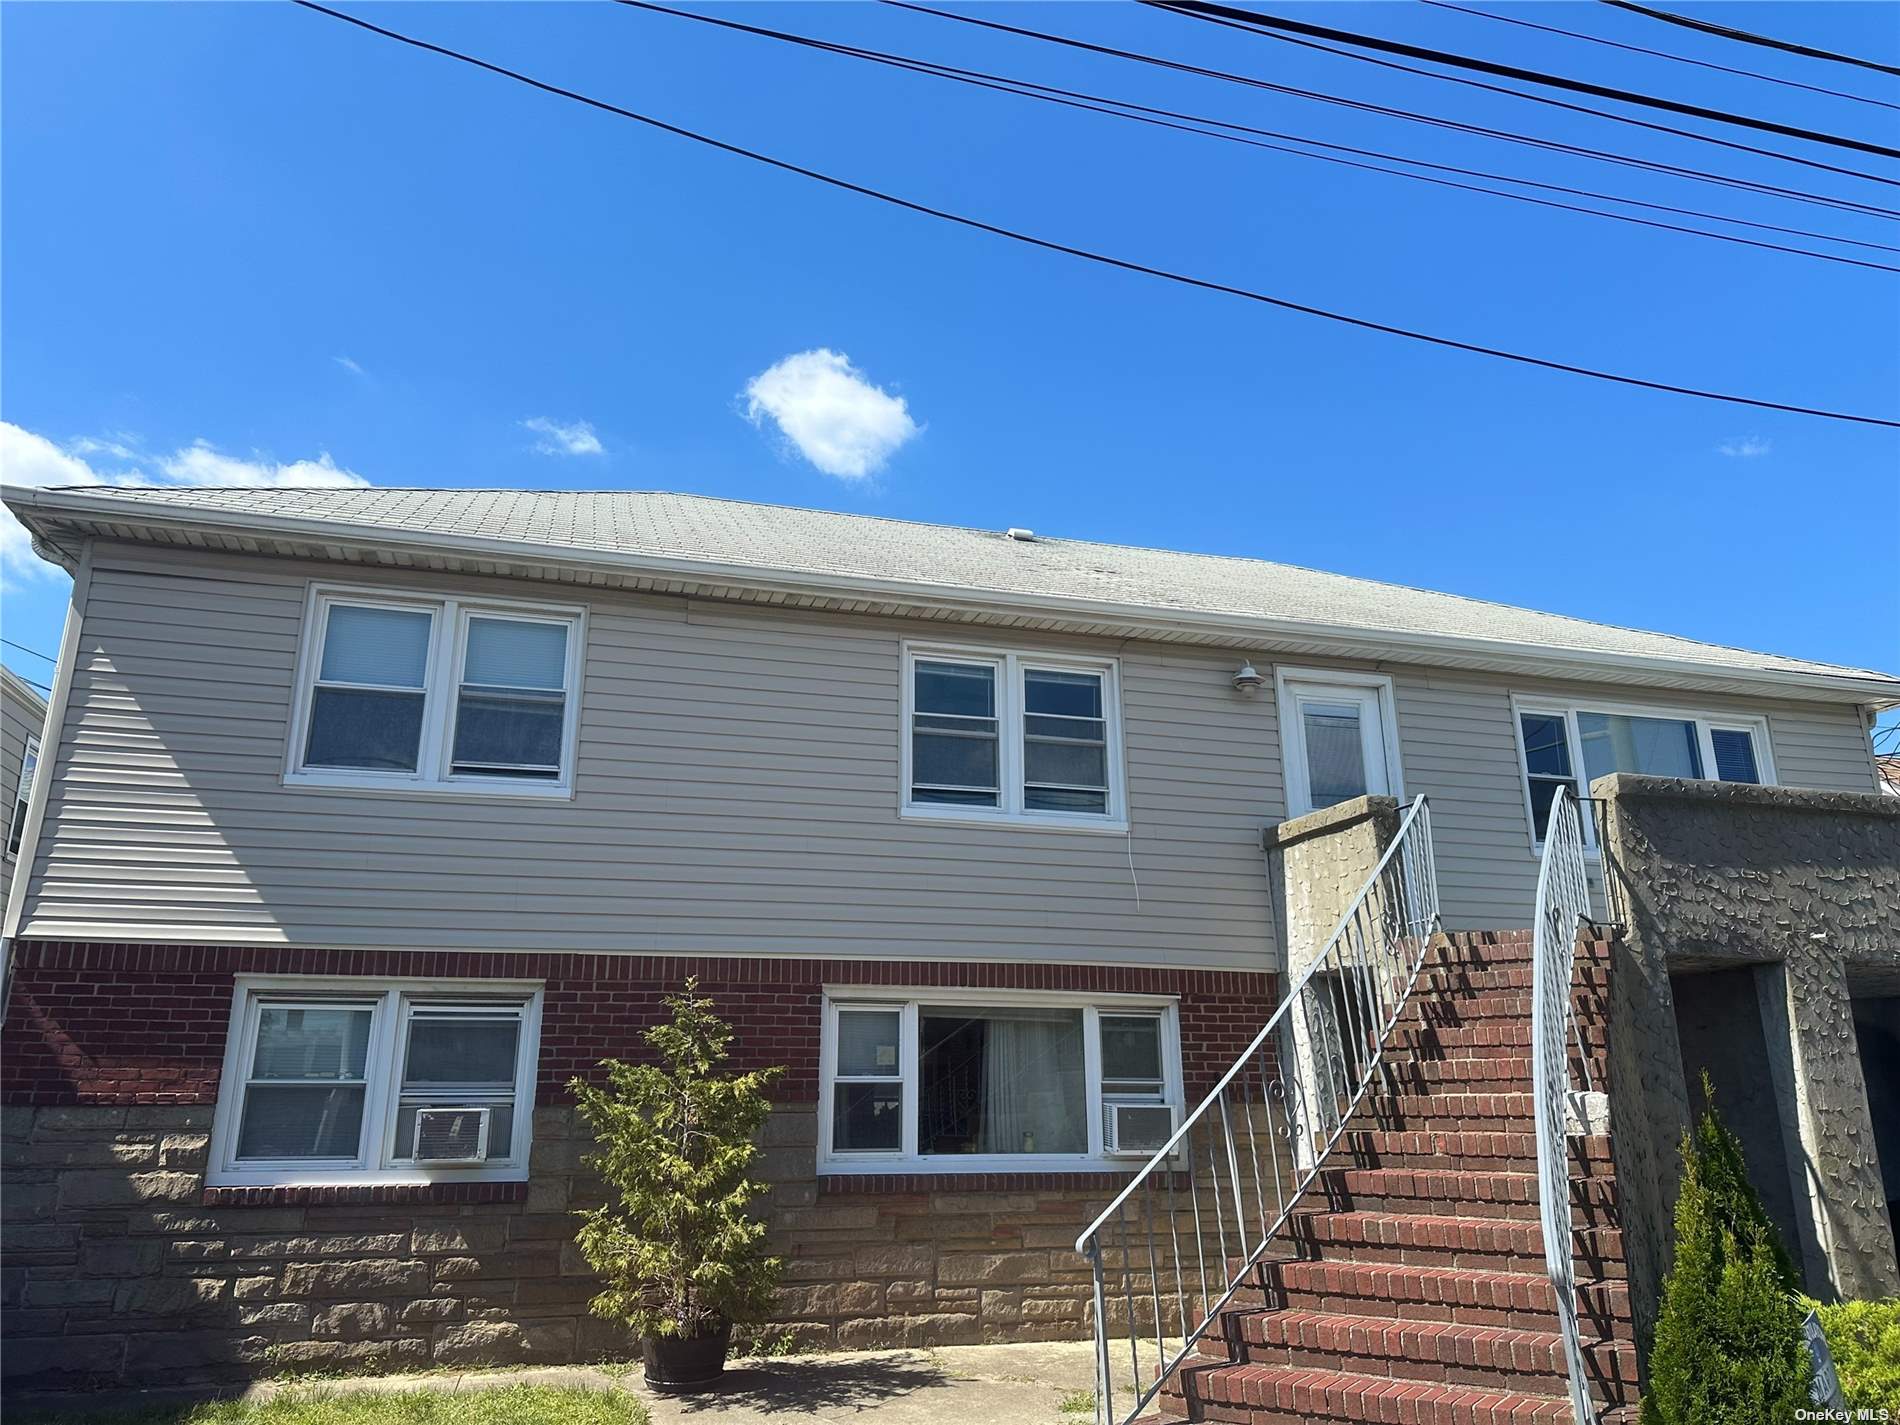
left=819, top=990, right=1180, bottom=1172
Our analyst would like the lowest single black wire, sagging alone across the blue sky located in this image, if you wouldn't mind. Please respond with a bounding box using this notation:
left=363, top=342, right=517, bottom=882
left=293, top=0, right=1900, bottom=429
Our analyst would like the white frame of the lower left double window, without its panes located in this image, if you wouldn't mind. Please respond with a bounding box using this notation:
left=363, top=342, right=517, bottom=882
left=205, top=975, right=543, bottom=1188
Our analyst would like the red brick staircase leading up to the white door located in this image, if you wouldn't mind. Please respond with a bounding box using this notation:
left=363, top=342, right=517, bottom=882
left=1155, top=931, right=1638, bottom=1425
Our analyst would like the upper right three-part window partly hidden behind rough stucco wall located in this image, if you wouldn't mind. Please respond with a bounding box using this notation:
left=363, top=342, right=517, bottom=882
left=1516, top=699, right=1775, bottom=846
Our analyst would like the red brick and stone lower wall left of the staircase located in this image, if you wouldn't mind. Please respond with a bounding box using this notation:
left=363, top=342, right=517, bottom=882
left=0, top=942, right=1273, bottom=1398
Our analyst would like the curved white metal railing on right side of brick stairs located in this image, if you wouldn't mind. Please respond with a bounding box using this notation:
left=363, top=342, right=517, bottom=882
left=1531, top=787, right=1596, bottom=1425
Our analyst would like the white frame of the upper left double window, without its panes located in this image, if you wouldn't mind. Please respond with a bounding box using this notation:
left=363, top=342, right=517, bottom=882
left=283, top=583, right=587, bottom=798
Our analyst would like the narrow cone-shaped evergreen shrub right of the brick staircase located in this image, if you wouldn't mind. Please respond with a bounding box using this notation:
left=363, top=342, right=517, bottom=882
left=1642, top=1074, right=1815, bottom=1425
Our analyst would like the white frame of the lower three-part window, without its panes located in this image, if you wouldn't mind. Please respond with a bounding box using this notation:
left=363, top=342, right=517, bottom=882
left=819, top=984, right=1184, bottom=1178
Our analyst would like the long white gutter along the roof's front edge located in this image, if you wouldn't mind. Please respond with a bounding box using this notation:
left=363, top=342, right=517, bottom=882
left=0, top=485, right=1900, bottom=707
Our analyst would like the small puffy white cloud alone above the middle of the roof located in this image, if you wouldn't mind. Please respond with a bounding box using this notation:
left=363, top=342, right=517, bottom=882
left=745, top=346, right=918, bottom=481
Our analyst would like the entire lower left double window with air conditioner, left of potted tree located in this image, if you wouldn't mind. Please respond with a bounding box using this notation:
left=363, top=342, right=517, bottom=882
left=209, top=977, right=542, bottom=1186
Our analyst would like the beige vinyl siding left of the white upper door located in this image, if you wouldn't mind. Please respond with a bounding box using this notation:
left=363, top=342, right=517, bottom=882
left=21, top=545, right=1281, bottom=969
